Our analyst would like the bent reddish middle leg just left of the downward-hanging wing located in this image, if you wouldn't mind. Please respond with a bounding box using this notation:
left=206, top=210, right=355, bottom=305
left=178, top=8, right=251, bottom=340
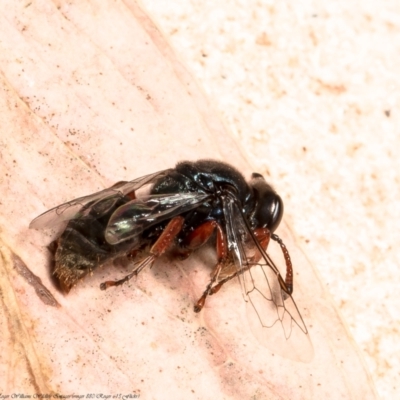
left=184, top=221, right=228, bottom=312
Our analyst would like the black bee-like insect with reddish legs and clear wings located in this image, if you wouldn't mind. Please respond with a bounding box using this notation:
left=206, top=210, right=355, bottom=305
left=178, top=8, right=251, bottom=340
left=30, top=160, right=312, bottom=361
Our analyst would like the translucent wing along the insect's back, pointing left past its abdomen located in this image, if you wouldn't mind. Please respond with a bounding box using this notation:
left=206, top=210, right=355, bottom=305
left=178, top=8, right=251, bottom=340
left=29, top=169, right=170, bottom=229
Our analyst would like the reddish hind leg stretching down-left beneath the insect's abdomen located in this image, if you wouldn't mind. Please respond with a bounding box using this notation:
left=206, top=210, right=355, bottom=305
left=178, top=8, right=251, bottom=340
left=100, top=217, right=184, bottom=290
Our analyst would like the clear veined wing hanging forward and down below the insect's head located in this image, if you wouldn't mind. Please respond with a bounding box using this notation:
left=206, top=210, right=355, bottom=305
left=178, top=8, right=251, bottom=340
left=223, top=196, right=314, bottom=362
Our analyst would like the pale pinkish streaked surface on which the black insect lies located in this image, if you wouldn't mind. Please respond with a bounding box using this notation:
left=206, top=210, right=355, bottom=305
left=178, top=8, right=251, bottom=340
left=0, top=1, right=388, bottom=399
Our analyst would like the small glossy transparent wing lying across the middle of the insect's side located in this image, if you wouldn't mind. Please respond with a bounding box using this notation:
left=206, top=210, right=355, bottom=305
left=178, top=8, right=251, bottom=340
left=105, top=193, right=209, bottom=245
